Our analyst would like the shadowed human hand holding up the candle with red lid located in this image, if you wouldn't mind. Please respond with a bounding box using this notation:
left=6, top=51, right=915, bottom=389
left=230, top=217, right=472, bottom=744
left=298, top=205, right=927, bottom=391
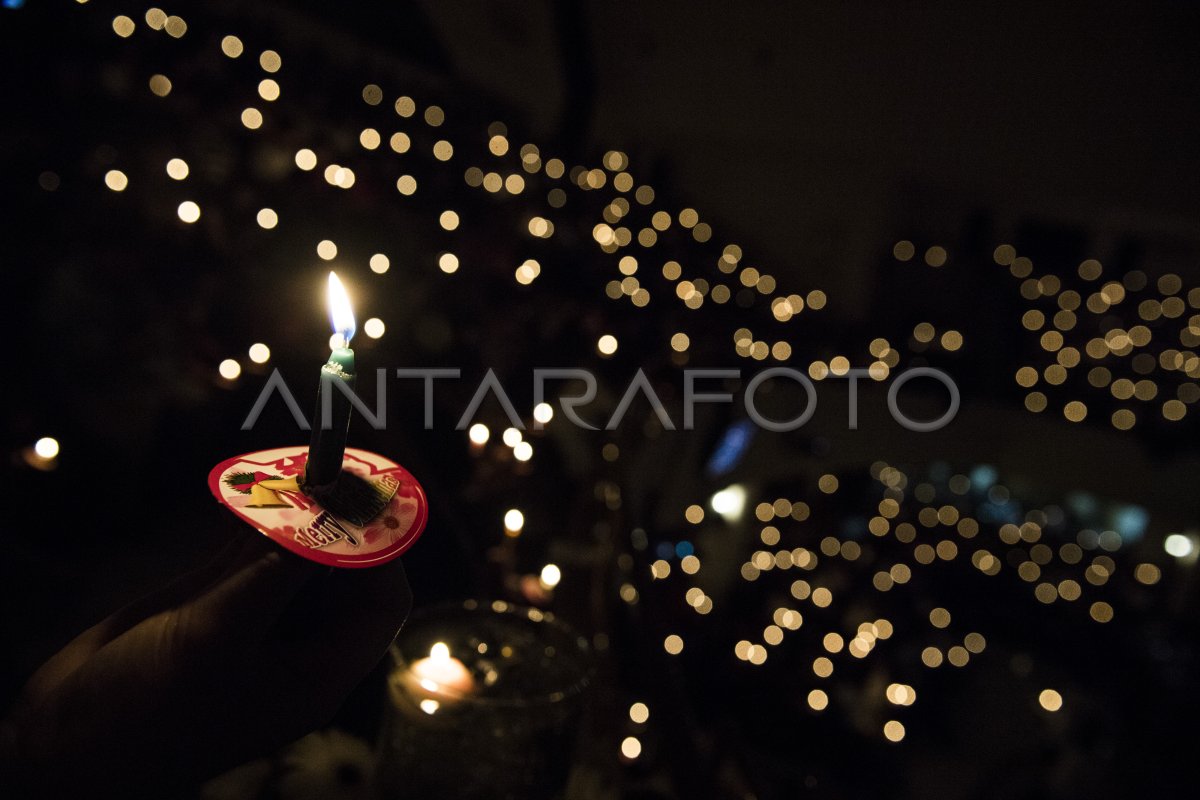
left=0, top=537, right=412, bottom=796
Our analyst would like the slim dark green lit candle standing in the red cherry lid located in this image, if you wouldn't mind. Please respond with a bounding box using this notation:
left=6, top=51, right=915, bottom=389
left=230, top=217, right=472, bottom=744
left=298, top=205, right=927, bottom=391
left=305, top=272, right=355, bottom=486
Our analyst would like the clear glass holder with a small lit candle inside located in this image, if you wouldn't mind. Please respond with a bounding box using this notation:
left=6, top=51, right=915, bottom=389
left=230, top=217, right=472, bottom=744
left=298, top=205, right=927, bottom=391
left=377, top=601, right=593, bottom=800
